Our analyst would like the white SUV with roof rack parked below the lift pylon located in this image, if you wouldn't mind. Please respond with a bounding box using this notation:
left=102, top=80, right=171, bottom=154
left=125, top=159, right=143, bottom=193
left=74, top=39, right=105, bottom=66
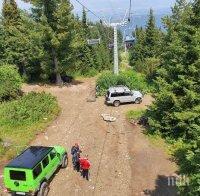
left=106, top=86, right=143, bottom=107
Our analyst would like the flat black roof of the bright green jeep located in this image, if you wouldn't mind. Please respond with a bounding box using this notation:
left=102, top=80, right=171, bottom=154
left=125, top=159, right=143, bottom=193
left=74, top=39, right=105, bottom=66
left=6, top=146, right=53, bottom=169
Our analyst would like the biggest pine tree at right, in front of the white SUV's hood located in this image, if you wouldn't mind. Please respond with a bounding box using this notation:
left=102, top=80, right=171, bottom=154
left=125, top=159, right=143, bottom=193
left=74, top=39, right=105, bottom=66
left=150, top=0, right=200, bottom=140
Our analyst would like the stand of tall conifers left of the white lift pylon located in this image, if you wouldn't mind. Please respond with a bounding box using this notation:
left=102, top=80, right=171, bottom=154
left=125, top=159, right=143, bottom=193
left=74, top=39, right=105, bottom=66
left=0, top=0, right=113, bottom=84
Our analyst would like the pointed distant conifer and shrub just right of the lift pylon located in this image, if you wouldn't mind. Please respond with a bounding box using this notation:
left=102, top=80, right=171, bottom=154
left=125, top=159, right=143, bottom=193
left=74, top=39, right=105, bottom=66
left=130, top=9, right=163, bottom=80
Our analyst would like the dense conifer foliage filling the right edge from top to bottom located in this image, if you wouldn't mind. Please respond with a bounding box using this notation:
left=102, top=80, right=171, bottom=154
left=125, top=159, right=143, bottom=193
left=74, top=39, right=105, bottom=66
left=145, top=0, right=200, bottom=195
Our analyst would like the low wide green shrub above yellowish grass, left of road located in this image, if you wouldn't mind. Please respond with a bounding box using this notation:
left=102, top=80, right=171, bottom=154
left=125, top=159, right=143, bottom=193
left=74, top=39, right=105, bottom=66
left=0, top=92, right=57, bottom=126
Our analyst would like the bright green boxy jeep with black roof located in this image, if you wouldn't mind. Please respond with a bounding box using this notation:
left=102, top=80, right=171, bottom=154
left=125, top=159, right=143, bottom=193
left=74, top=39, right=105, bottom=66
left=4, top=146, right=68, bottom=196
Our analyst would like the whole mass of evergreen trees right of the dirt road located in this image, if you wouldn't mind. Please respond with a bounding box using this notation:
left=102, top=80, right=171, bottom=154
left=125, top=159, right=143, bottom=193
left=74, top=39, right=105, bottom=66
left=130, top=0, right=200, bottom=195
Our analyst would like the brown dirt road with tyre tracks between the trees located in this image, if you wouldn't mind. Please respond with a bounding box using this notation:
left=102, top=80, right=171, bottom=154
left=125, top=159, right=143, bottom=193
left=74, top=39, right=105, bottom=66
left=0, top=79, right=176, bottom=196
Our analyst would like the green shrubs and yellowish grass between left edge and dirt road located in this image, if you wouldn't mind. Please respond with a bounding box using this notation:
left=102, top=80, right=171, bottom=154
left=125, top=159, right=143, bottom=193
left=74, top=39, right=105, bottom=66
left=0, top=92, right=60, bottom=160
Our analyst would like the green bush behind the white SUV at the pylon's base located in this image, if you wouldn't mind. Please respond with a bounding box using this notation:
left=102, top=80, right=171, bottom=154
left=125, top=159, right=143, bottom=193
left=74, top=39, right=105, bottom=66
left=97, top=71, right=149, bottom=95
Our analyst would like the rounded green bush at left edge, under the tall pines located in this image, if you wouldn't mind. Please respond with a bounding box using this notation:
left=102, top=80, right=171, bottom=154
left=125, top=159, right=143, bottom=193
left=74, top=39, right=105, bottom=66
left=0, top=64, right=22, bottom=101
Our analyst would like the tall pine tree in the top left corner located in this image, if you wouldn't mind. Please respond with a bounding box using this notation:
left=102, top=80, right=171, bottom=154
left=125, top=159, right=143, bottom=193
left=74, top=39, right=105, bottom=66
left=0, top=0, right=42, bottom=78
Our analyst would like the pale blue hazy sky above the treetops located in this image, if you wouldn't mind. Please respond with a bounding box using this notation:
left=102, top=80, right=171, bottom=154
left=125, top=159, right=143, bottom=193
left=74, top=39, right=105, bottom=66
left=0, top=0, right=175, bottom=15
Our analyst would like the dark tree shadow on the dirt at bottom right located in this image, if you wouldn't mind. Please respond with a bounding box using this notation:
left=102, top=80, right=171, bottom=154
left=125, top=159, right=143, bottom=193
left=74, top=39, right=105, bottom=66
left=143, top=175, right=178, bottom=196
